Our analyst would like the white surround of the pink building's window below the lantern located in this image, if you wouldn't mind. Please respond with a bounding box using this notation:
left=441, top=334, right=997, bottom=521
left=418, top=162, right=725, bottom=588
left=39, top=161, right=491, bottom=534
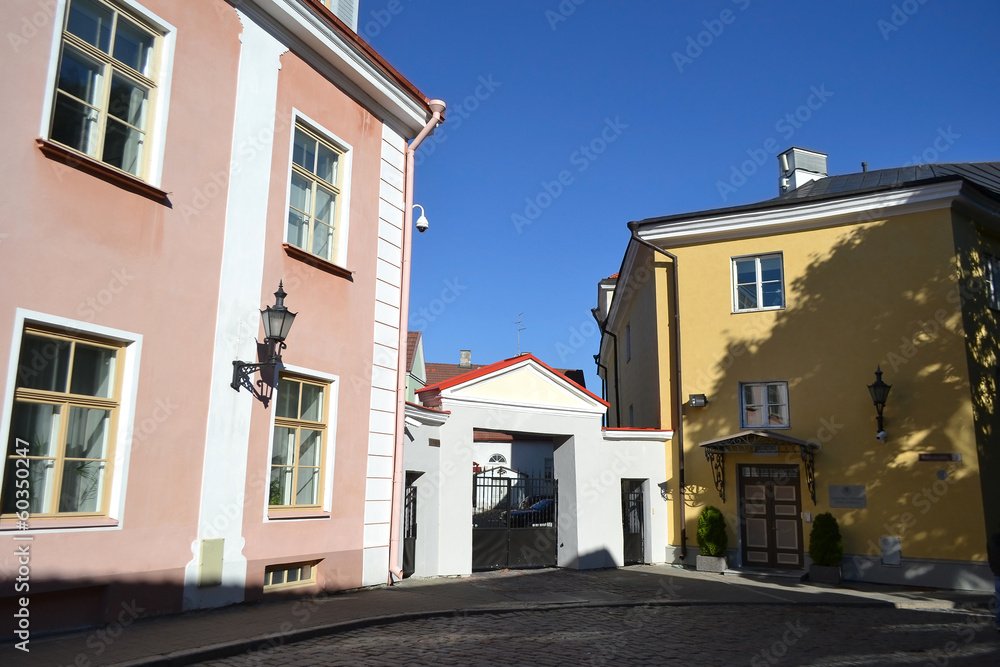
left=261, top=364, right=340, bottom=523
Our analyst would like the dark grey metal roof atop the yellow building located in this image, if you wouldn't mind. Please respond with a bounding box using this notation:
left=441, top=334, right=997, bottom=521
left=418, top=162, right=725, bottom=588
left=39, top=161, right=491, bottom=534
left=629, top=162, right=1000, bottom=229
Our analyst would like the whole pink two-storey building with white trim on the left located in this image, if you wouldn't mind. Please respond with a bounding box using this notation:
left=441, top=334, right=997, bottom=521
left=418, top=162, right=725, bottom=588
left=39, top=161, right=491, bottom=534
left=0, top=0, right=443, bottom=637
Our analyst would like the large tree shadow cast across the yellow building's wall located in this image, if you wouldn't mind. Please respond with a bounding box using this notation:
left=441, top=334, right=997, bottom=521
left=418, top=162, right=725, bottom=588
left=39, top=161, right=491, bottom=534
left=681, top=213, right=1000, bottom=580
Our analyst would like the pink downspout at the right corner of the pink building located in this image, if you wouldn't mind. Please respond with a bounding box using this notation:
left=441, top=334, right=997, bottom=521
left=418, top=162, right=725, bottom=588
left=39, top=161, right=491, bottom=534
left=388, top=100, right=445, bottom=585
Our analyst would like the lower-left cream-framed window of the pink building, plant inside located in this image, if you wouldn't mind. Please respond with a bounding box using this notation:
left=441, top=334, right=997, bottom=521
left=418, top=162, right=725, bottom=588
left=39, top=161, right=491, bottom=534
left=2, top=328, right=122, bottom=517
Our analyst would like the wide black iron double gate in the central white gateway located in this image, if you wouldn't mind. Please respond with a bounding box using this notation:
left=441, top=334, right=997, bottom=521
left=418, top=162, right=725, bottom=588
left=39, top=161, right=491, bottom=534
left=472, top=468, right=558, bottom=570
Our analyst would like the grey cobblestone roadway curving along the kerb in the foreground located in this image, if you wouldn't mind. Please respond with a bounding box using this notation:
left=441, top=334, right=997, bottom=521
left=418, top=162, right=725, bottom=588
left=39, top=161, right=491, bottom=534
left=201, top=605, right=1000, bottom=667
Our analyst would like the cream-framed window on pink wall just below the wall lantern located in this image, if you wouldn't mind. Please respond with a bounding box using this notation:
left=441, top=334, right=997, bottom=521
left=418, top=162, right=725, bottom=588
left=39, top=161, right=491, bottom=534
left=268, top=377, right=329, bottom=509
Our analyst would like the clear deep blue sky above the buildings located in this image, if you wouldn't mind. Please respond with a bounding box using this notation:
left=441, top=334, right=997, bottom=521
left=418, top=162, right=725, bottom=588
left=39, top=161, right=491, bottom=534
left=368, top=0, right=1000, bottom=394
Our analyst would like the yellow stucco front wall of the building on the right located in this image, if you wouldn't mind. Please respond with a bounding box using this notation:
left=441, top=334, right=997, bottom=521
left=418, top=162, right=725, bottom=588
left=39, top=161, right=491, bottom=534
left=652, top=211, right=985, bottom=560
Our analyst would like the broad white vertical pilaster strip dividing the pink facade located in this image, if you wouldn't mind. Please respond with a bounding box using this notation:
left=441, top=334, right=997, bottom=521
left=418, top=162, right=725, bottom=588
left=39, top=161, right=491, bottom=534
left=183, top=9, right=287, bottom=610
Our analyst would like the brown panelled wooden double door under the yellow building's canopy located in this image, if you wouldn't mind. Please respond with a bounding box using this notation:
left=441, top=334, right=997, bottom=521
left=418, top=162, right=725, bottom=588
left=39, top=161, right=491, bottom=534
left=739, top=465, right=803, bottom=569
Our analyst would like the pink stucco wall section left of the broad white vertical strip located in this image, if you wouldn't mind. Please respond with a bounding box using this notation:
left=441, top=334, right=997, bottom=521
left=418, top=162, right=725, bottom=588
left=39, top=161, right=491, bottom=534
left=0, top=0, right=241, bottom=629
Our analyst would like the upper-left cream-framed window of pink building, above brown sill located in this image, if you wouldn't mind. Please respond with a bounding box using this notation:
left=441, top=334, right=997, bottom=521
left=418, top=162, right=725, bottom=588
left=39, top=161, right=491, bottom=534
left=49, top=0, right=162, bottom=178
